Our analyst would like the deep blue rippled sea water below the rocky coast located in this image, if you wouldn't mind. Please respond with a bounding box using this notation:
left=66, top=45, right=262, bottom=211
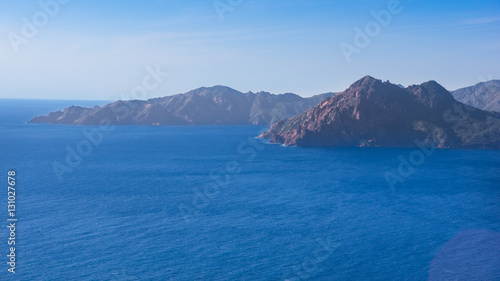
left=0, top=100, right=500, bottom=281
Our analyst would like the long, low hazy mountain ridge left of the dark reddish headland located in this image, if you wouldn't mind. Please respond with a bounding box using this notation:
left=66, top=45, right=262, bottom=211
left=30, top=86, right=334, bottom=125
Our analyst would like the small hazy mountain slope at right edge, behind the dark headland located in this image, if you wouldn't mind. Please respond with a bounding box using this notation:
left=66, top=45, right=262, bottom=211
left=451, top=80, right=500, bottom=112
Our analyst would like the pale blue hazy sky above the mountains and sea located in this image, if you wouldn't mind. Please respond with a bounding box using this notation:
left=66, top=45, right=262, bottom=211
left=0, top=0, right=500, bottom=100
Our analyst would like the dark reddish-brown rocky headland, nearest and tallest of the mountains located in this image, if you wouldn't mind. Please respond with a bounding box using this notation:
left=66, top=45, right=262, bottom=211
left=260, top=76, right=500, bottom=149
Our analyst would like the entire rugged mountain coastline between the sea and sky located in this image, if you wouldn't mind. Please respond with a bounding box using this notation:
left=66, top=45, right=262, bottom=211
left=30, top=76, right=500, bottom=148
